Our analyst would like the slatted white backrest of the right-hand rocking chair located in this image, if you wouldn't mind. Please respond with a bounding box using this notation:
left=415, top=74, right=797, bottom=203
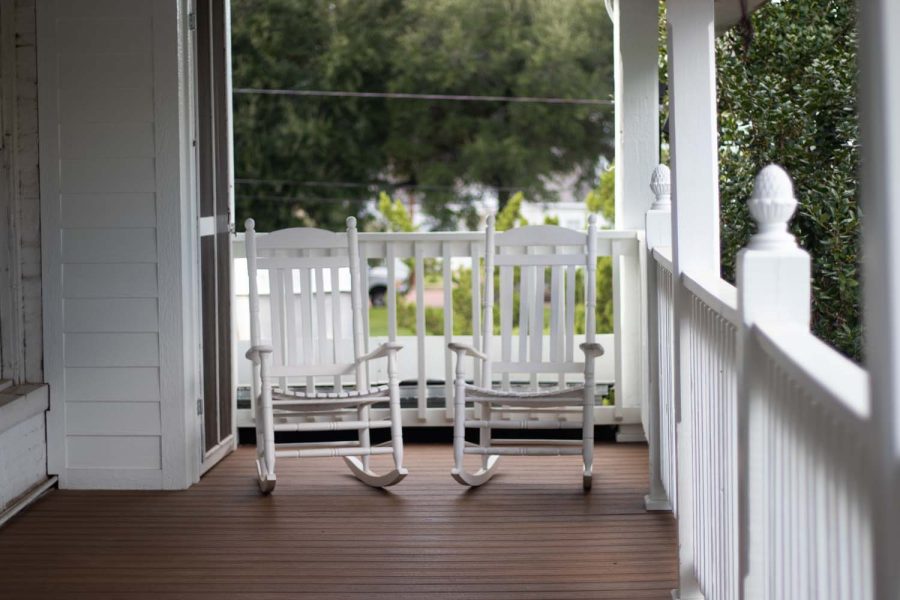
left=481, top=219, right=597, bottom=391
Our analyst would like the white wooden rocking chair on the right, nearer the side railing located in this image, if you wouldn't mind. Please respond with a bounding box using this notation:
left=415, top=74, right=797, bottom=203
left=449, top=215, right=603, bottom=490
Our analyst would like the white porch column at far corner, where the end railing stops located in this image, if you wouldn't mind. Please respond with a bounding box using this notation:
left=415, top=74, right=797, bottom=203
left=607, top=0, right=659, bottom=440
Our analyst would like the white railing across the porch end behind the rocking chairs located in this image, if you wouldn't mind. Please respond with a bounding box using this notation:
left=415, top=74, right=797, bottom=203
left=232, top=231, right=643, bottom=427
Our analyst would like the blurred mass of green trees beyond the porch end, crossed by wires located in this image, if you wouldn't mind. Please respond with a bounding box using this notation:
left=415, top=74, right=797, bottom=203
left=232, top=0, right=613, bottom=229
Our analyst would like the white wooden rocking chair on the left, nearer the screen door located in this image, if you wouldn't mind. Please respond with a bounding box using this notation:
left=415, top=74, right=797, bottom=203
left=246, top=217, right=407, bottom=494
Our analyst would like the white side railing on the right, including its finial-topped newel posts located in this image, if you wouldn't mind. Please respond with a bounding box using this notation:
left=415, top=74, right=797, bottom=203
left=647, top=167, right=874, bottom=600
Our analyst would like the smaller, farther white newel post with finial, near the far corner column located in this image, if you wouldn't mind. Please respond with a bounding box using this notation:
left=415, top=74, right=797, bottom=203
left=644, top=165, right=672, bottom=510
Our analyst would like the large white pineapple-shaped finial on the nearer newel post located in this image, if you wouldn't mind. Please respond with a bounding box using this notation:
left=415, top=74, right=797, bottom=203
left=747, top=165, right=797, bottom=250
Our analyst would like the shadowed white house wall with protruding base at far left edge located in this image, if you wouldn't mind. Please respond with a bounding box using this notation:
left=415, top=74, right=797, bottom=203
left=0, top=0, right=47, bottom=512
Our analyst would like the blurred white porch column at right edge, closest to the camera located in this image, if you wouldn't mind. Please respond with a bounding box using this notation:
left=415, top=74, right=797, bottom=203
left=859, top=0, right=900, bottom=598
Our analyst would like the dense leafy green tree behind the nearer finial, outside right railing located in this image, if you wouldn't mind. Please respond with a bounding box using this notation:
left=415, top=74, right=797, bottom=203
left=717, top=0, right=862, bottom=359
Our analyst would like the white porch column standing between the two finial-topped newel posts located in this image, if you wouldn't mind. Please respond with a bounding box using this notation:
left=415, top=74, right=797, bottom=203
left=666, top=0, right=719, bottom=598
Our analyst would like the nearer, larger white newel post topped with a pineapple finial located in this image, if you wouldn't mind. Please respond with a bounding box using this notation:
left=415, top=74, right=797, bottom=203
left=737, top=165, right=811, bottom=598
